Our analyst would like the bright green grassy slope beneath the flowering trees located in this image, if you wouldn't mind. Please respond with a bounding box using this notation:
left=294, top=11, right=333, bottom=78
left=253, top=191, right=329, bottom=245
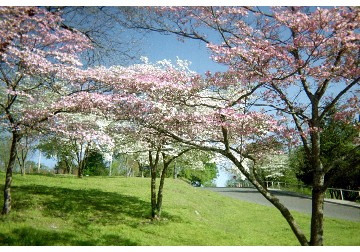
left=0, top=173, right=360, bottom=246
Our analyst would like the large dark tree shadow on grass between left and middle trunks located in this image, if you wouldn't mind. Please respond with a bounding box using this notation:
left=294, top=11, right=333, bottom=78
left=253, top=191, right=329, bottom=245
left=13, top=185, right=150, bottom=222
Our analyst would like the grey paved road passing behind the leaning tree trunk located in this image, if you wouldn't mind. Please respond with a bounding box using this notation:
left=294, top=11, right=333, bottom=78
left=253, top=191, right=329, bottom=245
left=207, top=187, right=360, bottom=222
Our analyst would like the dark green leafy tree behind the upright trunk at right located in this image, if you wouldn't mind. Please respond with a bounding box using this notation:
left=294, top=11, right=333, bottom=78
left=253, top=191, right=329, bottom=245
left=290, top=111, right=360, bottom=190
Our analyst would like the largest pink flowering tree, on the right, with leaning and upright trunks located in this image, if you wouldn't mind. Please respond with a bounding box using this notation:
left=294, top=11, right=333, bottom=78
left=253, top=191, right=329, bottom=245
left=121, top=7, right=360, bottom=245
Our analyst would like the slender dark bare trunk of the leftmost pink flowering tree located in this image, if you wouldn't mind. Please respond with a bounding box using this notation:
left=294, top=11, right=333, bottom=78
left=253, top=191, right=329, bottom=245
left=2, top=132, right=20, bottom=214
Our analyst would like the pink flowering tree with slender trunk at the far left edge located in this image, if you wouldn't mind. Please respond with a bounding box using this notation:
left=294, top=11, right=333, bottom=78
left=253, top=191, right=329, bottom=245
left=0, top=7, right=95, bottom=214
